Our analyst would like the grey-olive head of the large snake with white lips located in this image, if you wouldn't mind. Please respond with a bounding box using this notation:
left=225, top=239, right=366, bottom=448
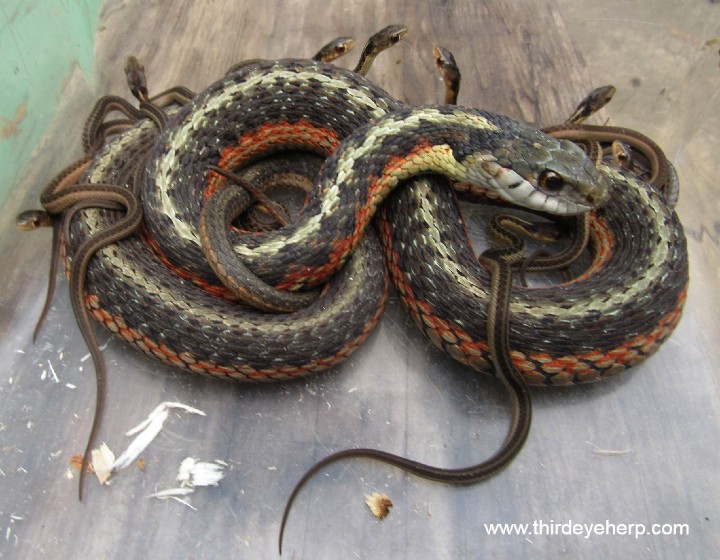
left=480, top=125, right=609, bottom=216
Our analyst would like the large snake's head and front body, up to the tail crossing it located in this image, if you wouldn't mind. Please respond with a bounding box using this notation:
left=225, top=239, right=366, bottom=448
left=217, top=107, right=605, bottom=287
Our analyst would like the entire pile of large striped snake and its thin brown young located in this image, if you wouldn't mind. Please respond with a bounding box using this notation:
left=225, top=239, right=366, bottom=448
left=19, top=26, right=688, bottom=552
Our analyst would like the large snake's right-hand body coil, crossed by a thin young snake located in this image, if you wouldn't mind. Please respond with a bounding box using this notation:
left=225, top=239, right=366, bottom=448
left=380, top=166, right=688, bottom=385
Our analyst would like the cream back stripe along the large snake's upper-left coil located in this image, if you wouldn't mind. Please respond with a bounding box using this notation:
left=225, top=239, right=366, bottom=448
left=150, top=70, right=385, bottom=247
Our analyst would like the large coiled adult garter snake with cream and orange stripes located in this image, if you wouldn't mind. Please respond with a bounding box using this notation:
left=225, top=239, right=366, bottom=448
left=63, top=60, right=687, bottom=384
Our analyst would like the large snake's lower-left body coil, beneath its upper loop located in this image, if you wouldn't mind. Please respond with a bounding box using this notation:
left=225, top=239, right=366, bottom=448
left=71, top=117, right=387, bottom=381
